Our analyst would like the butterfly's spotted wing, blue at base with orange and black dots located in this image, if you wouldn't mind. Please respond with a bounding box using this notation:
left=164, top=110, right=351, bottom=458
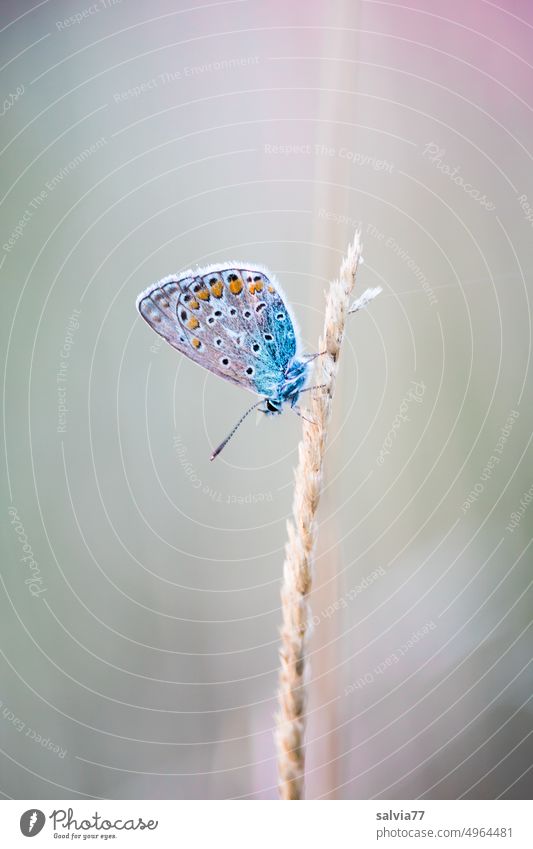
left=137, top=263, right=297, bottom=397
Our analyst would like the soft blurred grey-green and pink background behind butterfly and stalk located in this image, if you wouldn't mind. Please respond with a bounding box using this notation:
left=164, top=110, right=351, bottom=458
left=0, top=0, right=533, bottom=799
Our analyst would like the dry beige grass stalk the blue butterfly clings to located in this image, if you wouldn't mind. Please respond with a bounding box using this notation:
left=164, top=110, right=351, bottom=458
left=276, top=232, right=361, bottom=799
